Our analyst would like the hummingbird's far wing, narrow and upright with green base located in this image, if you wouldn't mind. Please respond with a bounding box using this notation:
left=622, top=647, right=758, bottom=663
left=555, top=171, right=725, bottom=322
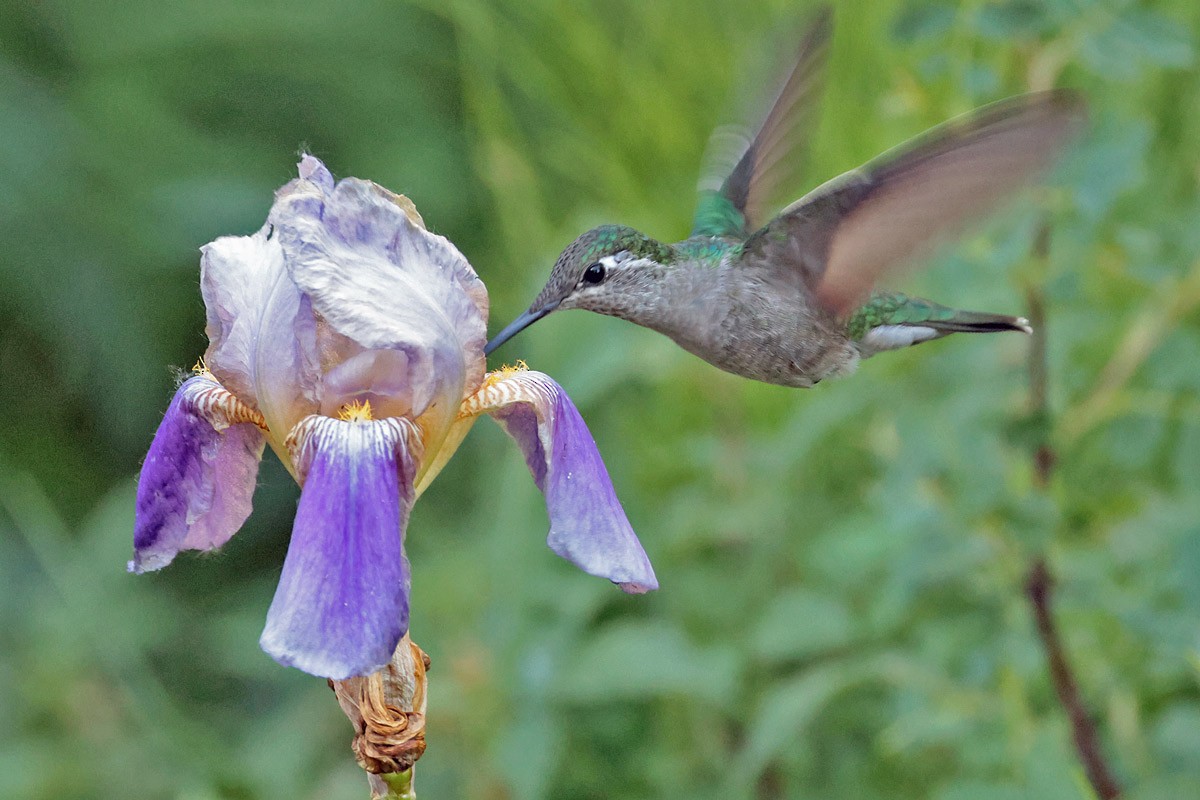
left=691, top=6, right=833, bottom=239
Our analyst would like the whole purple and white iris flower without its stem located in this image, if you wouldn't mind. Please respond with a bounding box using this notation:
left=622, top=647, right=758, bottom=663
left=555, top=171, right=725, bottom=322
left=130, top=156, right=658, bottom=680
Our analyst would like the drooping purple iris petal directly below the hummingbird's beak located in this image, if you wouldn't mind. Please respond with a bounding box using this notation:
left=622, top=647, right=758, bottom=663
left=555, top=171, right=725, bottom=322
left=463, top=371, right=659, bottom=593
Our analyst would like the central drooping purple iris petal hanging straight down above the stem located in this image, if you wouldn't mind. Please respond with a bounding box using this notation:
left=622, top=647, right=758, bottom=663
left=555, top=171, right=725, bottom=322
left=260, top=416, right=420, bottom=680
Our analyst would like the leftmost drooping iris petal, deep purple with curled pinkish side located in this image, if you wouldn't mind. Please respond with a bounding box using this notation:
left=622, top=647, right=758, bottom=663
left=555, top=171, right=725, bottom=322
left=128, top=374, right=264, bottom=572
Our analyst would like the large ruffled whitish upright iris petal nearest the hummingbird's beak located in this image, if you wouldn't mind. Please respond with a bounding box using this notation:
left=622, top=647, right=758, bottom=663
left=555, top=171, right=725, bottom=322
left=270, top=162, right=487, bottom=445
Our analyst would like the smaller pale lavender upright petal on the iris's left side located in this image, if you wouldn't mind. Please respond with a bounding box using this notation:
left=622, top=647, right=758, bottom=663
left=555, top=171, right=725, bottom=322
left=200, top=221, right=319, bottom=435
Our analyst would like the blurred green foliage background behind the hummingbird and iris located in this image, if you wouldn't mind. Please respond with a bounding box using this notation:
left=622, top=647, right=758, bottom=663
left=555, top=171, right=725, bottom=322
left=0, top=0, right=1200, bottom=800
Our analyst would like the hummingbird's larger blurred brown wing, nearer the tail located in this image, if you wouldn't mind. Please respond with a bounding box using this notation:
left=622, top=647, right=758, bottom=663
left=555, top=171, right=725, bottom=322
left=740, top=90, right=1086, bottom=317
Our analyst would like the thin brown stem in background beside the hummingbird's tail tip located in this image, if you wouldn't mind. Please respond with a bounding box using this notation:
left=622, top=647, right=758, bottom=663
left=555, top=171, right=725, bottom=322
left=1025, top=222, right=1121, bottom=800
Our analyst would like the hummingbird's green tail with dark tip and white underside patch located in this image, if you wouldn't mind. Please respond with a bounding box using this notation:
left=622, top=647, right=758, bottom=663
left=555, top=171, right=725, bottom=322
left=847, top=293, right=1033, bottom=359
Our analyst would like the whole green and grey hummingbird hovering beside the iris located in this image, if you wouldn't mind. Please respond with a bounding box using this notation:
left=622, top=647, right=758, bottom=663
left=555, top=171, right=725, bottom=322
left=485, top=10, right=1084, bottom=386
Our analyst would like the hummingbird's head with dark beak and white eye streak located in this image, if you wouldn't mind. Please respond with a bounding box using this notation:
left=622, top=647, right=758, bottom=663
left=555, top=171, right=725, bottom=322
left=484, top=225, right=671, bottom=355
